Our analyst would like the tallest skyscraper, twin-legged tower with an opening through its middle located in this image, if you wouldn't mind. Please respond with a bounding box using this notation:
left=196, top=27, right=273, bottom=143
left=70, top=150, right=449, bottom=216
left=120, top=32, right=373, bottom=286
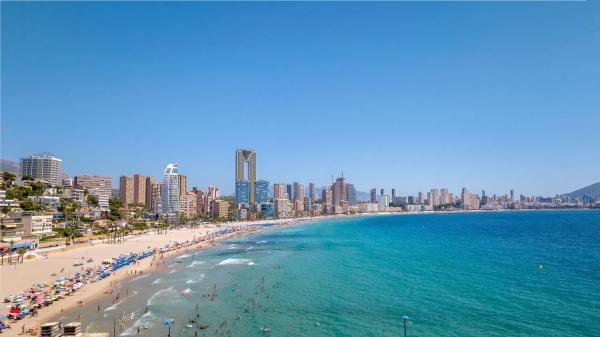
left=235, top=149, right=256, bottom=204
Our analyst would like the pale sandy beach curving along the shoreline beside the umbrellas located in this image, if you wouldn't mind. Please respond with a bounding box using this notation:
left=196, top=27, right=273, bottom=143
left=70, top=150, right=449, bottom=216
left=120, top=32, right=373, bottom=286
left=0, top=217, right=331, bottom=336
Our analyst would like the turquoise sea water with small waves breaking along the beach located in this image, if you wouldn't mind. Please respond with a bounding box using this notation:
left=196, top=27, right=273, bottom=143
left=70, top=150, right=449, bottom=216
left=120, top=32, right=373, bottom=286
left=64, top=211, right=600, bottom=337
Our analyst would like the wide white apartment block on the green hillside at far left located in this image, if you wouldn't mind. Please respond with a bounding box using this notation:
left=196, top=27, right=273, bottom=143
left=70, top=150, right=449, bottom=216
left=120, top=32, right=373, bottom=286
left=21, top=153, right=62, bottom=185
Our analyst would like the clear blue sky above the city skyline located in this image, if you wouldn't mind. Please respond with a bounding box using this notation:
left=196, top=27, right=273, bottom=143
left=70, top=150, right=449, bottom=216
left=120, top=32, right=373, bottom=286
left=1, top=2, right=600, bottom=195
